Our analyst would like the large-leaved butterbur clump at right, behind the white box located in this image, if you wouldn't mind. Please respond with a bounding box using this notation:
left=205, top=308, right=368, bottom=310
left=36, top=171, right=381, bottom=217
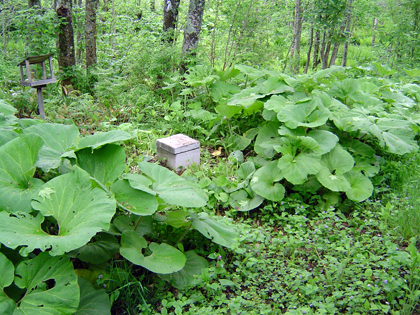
left=185, top=65, right=420, bottom=211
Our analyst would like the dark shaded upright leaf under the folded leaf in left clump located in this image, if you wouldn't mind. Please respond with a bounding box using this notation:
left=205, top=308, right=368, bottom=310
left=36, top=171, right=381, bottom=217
left=76, top=144, right=126, bottom=185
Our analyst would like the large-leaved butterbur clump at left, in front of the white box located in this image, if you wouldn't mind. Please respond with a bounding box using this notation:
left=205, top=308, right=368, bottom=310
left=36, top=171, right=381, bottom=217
left=0, top=102, right=237, bottom=314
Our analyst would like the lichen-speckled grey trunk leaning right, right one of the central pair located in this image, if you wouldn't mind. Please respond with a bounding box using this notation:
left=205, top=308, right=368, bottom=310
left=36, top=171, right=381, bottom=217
left=181, top=0, right=206, bottom=72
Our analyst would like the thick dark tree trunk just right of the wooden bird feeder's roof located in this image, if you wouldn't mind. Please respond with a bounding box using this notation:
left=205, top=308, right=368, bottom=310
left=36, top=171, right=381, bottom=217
left=55, top=0, right=76, bottom=86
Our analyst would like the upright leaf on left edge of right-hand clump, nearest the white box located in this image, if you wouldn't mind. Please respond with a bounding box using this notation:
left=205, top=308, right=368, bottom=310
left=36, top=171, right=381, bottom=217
left=254, top=122, right=280, bottom=158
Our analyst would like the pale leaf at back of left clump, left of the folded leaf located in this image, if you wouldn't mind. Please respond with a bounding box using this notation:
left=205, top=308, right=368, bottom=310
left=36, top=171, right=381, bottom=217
left=23, top=124, right=79, bottom=172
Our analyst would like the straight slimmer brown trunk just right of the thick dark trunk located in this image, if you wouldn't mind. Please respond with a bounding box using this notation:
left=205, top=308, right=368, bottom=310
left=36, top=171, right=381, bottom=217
left=85, top=0, right=98, bottom=71
